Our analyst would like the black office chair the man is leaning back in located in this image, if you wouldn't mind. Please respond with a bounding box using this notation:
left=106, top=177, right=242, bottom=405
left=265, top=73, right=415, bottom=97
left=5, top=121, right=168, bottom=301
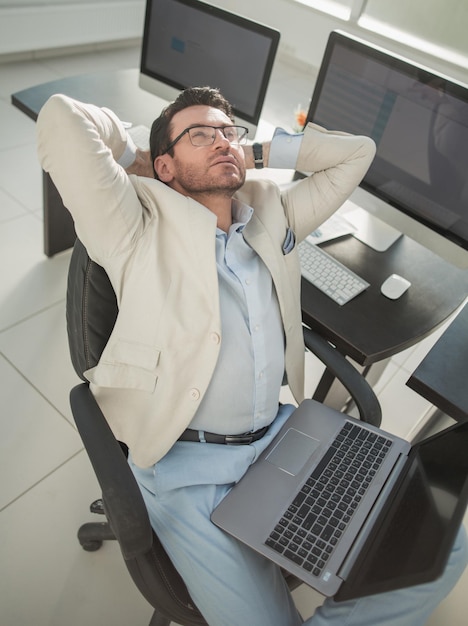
left=67, top=240, right=381, bottom=626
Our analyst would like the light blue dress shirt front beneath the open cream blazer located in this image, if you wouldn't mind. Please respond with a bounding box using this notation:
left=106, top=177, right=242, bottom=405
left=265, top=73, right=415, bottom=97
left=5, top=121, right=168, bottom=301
left=190, top=200, right=284, bottom=434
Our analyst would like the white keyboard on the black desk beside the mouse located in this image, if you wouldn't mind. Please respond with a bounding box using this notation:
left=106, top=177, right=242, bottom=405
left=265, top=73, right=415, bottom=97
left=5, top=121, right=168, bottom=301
left=298, top=240, right=369, bottom=306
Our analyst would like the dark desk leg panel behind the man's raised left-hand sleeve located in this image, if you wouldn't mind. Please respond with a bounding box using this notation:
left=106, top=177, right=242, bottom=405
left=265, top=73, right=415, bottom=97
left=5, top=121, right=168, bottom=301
left=42, top=172, right=76, bottom=257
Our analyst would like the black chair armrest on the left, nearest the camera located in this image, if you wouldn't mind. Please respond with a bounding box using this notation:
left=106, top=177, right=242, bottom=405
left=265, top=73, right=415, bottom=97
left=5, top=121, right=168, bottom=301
left=70, top=383, right=153, bottom=559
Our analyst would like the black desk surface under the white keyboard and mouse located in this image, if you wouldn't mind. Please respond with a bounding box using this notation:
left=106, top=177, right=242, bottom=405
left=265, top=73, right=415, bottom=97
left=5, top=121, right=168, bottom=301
left=302, top=236, right=468, bottom=365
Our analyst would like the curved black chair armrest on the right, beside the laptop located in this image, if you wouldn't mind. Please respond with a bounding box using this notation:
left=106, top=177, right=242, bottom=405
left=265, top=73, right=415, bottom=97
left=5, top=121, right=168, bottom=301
left=303, top=327, right=382, bottom=426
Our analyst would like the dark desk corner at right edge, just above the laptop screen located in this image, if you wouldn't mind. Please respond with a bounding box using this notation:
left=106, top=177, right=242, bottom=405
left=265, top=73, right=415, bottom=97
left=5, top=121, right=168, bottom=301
left=406, top=304, right=468, bottom=420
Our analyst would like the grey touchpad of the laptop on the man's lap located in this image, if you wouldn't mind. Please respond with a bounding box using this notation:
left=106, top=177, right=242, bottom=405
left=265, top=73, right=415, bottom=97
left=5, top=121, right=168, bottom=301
left=266, top=428, right=320, bottom=476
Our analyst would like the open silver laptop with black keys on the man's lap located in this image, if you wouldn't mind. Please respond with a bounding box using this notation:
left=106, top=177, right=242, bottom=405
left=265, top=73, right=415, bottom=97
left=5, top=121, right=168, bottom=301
left=212, top=400, right=468, bottom=601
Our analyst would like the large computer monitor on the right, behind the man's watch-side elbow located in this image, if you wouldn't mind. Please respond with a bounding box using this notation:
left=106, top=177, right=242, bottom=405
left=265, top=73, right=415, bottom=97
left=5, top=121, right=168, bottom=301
left=307, top=31, right=468, bottom=268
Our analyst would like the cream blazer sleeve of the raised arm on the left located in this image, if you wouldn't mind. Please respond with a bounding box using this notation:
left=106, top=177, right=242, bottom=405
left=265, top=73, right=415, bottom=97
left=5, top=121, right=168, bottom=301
left=37, top=94, right=143, bottom=261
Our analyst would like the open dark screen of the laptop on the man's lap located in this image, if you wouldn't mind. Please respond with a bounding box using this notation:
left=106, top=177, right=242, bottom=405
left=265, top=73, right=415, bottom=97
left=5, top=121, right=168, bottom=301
left=335, top=422, right=468, bottom=600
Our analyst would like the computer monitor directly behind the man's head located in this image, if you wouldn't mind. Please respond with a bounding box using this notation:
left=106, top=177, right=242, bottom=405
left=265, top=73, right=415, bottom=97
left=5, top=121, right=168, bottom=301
left=139, top=0, right=280, bottom=139
